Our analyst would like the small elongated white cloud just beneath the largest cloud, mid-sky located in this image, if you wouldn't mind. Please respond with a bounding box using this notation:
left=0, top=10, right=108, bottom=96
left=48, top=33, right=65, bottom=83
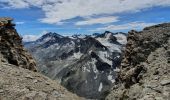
left=75, top=16, right=119, bottom=25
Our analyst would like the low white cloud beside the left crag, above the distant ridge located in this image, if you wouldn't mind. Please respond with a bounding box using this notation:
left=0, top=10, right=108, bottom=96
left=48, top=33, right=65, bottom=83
left=22, top=31, right=48, bottom=42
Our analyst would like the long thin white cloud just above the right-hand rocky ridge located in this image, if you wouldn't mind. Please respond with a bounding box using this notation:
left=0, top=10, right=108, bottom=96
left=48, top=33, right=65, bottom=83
left=92, top=22, right=156, bottom=31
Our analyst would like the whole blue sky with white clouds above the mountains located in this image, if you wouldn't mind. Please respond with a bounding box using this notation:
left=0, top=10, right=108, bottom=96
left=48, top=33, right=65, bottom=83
left=0, top=0, right=170, bottom=41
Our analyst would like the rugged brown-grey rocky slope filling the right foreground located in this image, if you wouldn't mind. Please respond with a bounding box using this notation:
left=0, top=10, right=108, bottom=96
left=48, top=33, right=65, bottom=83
left=106, top=23, right=170, bottom=100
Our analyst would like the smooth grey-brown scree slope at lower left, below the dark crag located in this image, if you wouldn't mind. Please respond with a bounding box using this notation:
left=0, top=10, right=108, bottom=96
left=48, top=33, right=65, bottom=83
left=0, top=63, right=83, bottom=100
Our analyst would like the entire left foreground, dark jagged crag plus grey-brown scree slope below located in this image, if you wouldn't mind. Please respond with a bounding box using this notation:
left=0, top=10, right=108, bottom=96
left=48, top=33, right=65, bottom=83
left=0, top=18, right=83, bottom=100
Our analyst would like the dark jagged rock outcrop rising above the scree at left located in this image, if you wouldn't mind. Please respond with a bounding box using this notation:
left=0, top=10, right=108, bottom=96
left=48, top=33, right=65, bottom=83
left=0, top=19, right=37, bottom=71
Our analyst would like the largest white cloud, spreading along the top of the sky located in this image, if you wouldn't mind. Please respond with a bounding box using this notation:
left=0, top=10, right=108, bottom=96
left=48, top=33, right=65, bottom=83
left=0, top=0, right=170, bottom=24
